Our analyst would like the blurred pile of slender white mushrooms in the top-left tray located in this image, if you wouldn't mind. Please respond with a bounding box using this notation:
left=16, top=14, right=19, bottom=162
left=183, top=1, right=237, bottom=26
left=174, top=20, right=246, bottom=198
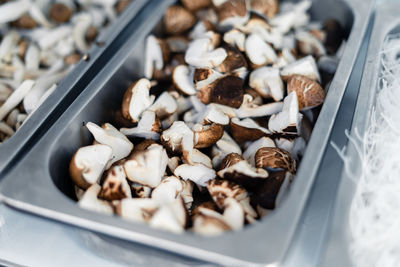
left=0, top=0, right=130, bottom=143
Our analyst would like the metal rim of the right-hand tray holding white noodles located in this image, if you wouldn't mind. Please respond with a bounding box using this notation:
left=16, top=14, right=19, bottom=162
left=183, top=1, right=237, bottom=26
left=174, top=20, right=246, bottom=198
left=321, top=1, right=400, bottom=266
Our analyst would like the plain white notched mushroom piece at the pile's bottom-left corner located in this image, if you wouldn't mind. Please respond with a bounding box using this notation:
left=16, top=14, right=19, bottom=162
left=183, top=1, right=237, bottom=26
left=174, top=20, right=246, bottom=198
left=78, top=183, right=114, bottom=215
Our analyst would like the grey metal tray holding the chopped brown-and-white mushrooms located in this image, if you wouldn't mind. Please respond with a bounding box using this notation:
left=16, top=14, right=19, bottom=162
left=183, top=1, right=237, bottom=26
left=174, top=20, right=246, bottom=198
left=0, top=0, right=373, bottom=266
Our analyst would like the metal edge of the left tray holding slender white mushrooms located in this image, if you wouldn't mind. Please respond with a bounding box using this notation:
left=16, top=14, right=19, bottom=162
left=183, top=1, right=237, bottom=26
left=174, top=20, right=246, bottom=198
left=0, top=0, right=147, bottom=176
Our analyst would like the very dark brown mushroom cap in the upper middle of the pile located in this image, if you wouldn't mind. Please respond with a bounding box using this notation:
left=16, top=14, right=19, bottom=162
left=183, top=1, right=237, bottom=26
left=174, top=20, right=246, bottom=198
left=210, top=75, right=244, bottom=108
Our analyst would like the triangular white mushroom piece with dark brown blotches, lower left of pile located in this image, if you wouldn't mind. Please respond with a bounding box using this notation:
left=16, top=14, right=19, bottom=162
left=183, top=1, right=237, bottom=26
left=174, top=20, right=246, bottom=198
left=99, top=165, right=132, bottom=201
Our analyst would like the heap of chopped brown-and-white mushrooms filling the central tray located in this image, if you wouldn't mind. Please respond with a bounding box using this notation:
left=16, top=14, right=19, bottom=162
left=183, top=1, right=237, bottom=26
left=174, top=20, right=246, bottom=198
left=70, top=0, right=343, bottom=235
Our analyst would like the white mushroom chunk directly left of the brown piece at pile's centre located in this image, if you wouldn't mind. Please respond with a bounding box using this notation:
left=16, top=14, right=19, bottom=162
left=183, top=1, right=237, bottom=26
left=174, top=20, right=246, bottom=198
left=161, top=121, right=194, bottom=153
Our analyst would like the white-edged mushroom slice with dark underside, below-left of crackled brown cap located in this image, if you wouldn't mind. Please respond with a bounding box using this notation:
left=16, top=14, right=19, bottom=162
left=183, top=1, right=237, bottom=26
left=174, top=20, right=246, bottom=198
left=218, top=160, right=268, bottom=189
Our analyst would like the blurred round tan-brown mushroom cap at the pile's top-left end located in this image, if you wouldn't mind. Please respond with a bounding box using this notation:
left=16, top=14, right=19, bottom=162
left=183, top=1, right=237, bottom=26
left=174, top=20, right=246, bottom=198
left=164, top=5, right=197, bottom=35
